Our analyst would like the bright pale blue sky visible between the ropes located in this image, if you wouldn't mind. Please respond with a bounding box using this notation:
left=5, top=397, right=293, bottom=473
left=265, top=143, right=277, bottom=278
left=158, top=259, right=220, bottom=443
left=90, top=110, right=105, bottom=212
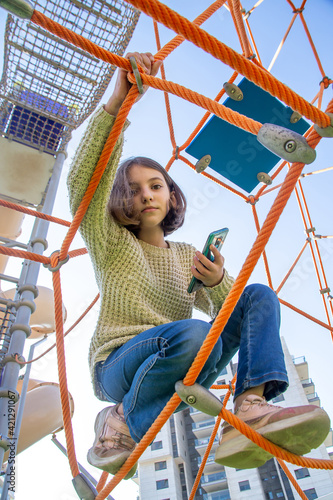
left=0, top=0, right=333, bottom=500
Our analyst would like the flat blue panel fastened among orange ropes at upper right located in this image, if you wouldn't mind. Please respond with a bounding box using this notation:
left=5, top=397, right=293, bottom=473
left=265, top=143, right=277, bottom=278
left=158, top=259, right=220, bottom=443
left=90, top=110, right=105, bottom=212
left=185, top=78, right=310, bottom=193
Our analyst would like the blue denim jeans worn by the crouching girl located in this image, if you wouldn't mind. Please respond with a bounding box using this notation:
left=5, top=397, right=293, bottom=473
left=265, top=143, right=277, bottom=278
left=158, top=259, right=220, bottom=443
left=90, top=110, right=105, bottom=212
left=96, top=284, right=288, bottom=442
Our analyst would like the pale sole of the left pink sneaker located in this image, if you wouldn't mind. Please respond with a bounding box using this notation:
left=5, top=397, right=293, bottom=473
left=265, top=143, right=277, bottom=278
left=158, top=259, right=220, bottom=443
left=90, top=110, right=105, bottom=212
left=87, top=408, right=137, bottom=479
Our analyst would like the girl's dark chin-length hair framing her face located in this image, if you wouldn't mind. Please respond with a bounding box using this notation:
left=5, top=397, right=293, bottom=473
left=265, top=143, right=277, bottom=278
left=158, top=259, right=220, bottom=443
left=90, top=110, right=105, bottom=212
left=108, top=156, right=186, bottom=236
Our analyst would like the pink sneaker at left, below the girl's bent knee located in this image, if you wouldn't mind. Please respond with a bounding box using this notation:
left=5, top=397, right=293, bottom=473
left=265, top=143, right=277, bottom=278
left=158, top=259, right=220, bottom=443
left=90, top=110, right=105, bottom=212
left=87, top=404, right=137, bottom=479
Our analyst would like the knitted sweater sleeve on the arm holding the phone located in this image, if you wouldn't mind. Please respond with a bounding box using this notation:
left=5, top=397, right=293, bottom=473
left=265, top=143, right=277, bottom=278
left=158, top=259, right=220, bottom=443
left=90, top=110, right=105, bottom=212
left=194, top=269, right=235, bottom=319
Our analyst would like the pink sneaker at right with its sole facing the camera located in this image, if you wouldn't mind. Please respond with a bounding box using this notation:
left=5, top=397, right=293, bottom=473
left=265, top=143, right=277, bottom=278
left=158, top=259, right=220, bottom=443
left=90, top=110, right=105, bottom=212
left=215, top=394, right=330, bottom=469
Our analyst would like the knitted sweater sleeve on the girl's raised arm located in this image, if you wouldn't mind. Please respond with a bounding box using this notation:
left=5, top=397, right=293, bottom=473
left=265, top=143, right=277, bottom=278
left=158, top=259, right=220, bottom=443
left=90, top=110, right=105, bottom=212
left=67, top=108, right=128, bottom=255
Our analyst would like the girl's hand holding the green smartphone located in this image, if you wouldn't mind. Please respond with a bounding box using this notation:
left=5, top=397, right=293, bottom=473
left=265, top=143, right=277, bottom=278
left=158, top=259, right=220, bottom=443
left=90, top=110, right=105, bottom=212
left=191, top=245, right=224, bottom=287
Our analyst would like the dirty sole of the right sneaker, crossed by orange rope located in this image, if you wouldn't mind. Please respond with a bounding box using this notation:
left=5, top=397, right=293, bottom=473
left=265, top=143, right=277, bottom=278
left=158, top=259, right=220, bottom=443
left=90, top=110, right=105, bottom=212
left=215, top=408, right=330, bottom=469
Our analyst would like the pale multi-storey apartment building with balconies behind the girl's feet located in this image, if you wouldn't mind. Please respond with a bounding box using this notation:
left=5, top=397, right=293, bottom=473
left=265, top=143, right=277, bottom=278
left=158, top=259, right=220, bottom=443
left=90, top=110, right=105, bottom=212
left=134, top=341, right=333, bottom=500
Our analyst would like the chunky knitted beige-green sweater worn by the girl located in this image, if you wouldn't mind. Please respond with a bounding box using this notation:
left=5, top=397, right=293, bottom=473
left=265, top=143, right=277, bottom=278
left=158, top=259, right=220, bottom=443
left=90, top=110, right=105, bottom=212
left=67, top=108, right=234, bottom=397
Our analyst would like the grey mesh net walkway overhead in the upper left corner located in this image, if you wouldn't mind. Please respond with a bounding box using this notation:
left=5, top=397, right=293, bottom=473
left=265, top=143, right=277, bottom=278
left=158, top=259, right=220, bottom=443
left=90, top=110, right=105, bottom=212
left=0, top=0, right=139, bottom=152
